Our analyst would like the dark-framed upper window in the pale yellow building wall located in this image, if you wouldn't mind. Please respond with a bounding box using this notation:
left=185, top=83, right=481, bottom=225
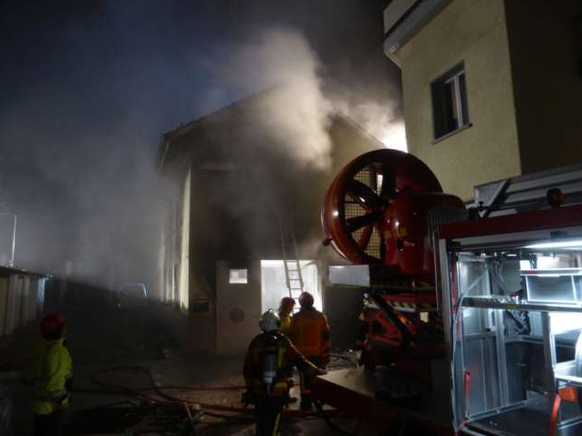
left=431, top=62, right=470, bottom=140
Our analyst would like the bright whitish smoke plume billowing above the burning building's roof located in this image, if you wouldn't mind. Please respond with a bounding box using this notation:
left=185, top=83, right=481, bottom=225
left=201, top=27, right=407, bottom=169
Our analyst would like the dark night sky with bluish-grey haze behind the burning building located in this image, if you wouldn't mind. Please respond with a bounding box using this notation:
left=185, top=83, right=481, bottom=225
left=0, top=0, right=401, bottom=290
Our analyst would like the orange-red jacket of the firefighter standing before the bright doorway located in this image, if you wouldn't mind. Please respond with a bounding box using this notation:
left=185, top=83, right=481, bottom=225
left=291, top=308, right=331, bottom=358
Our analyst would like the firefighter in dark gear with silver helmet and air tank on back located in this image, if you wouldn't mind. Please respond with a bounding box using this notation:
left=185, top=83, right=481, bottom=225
left=243, top=309, right=326, bottom=436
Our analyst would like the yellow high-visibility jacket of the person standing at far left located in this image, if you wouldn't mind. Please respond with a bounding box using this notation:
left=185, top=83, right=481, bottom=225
left=32, top=338, right=73, bottom=415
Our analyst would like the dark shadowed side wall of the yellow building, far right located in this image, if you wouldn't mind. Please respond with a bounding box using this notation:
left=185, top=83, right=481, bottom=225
left=505, top=0, right=582, bottom=174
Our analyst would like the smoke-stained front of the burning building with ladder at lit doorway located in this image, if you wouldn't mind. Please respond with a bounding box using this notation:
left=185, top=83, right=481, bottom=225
left=158, top=90, right=383, bottom=354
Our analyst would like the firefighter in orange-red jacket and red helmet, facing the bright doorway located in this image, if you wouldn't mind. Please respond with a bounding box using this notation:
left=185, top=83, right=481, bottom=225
left=291, top=292, right=331, bottom=410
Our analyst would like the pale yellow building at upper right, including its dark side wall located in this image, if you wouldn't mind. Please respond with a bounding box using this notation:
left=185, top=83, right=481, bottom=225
left=384, top=0, right=582, bottom=200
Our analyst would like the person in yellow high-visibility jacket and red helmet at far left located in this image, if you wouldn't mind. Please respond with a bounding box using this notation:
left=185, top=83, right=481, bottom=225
left=32, top=313, right=73, bottom=436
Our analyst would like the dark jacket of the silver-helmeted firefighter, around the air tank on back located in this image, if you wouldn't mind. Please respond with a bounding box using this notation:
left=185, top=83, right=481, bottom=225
left=243, top=332, right=317, bottom=397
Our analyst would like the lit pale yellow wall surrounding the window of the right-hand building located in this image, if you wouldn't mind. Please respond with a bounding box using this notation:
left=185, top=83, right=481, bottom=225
left=396, top=0, right=521, bottom=199
